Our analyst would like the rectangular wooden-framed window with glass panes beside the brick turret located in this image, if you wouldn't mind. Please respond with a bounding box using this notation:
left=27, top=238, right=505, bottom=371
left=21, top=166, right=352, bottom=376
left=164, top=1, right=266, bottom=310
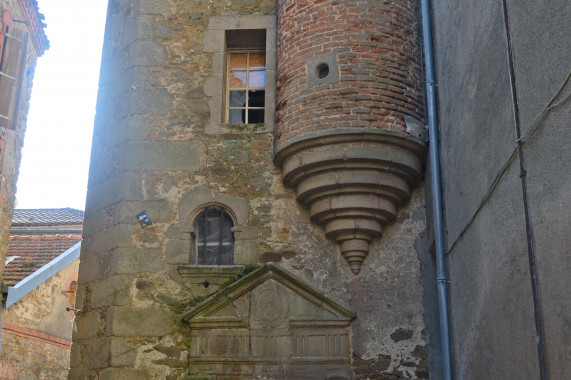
left=226, top=51, right=266, bottom=124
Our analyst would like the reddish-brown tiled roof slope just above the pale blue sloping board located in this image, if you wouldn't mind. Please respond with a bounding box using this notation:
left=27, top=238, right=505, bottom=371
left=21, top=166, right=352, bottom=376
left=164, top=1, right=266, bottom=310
left=3, top=235, right=81, bottom=286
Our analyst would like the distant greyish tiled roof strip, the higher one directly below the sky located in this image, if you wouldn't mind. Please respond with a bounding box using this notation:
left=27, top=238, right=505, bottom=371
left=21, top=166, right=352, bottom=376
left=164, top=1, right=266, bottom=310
left=12, top=208, right=83, bottom=227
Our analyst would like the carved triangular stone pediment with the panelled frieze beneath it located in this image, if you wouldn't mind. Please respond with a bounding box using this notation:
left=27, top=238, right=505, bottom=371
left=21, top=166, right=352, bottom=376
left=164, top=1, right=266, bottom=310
left=183, top=263, right=355, bottom=380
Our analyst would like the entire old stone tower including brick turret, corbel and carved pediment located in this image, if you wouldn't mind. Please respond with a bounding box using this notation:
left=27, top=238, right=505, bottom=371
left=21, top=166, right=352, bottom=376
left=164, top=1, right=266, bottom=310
left=69, top=0, right=435, bottom=380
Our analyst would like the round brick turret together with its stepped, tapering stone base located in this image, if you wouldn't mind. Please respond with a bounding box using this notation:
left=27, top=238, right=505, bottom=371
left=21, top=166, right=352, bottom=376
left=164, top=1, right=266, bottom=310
left=275, top=0, right=425, bottom=273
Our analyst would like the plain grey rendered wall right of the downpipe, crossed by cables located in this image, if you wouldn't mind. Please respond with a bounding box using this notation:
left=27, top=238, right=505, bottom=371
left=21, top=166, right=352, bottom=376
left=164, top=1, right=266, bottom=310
left=433, top=0, right=571, bottom=379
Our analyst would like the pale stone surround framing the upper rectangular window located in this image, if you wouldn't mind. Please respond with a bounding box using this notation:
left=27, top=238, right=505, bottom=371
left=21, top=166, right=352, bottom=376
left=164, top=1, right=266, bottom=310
left=202, top=15, right=276, bottom=134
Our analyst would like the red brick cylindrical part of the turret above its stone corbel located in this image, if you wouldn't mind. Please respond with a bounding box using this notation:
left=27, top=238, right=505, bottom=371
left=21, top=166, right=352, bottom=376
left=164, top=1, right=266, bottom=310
left=276, top=0, right=424, bottom=144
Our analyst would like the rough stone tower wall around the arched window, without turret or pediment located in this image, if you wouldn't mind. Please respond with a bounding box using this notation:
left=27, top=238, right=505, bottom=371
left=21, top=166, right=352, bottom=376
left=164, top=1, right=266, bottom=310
left=69, top=0, right=438, bottom=379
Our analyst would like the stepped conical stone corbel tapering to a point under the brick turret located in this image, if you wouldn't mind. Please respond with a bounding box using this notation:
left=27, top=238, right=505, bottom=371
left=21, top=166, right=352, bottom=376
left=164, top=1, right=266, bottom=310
left=275, top=128, right=426, bottom=274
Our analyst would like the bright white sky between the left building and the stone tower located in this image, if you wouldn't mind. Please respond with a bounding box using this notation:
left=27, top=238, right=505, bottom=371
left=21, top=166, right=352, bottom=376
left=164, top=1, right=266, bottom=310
left=15, top=0, right=107, bottom=210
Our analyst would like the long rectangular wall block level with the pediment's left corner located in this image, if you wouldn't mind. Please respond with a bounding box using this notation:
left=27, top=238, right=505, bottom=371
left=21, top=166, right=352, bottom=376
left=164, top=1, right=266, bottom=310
left=107, top=306, right=173, bottom=336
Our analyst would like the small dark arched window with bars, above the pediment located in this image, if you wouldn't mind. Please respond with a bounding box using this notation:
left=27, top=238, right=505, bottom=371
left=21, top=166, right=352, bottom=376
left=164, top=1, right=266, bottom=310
left=194, top=206, right=234, bottom=265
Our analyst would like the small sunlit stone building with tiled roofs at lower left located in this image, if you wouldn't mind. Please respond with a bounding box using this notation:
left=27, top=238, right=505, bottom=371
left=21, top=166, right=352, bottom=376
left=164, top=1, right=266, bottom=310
left=0, top=208, right=83, bottom=379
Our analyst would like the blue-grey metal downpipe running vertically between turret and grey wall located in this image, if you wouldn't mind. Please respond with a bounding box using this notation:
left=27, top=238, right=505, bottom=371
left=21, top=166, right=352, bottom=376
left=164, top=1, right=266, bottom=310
left=421, top=0, right=452, bottom=380
